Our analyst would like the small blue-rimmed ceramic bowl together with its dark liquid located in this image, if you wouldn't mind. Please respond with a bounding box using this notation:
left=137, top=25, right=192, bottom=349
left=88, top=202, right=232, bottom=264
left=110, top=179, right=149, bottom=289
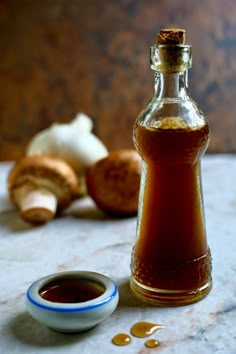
left=26, top=271, right=119, bottom=332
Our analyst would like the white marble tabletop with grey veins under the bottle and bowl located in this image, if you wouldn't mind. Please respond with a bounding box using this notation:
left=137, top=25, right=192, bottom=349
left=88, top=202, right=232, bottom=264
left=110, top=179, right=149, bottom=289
left=0, top=155, right=236, bottom=354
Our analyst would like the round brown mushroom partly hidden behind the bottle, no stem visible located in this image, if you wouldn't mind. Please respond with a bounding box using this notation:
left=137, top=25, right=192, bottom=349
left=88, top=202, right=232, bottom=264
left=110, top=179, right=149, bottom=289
left=87, top=149, right=141, bottom=216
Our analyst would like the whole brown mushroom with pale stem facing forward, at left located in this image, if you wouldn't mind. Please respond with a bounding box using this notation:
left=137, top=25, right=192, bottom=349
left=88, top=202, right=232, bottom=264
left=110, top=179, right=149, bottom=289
left=8, top=155, right=78, bottom=224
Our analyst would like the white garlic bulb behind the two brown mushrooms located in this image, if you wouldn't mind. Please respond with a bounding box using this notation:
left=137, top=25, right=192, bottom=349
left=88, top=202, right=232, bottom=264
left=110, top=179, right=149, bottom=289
left=26, top=113, right=108, bottom=194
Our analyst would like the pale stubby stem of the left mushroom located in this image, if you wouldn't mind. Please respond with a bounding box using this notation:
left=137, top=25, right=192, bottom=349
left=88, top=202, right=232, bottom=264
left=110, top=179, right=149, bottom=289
left=17, top=185, right=57, bottom=224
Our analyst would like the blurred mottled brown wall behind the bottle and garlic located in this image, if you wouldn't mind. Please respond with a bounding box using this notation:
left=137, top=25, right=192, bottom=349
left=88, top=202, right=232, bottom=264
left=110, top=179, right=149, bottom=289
left=0, top=0, right=236, bottom=161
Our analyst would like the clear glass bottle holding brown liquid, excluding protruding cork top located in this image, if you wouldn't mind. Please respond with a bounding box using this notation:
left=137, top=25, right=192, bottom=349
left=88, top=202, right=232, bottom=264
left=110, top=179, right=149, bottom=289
left=130, top=30, right=212, bottom=305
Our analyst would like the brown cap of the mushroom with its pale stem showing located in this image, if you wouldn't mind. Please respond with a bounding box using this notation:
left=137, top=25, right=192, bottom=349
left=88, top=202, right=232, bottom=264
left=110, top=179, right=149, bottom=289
left=8, top=155, right=78, bottom=210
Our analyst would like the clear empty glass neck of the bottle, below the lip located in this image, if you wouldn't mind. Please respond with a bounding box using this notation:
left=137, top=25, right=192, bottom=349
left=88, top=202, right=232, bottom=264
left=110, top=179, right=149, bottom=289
left=154, top=70, right=188, bottom=99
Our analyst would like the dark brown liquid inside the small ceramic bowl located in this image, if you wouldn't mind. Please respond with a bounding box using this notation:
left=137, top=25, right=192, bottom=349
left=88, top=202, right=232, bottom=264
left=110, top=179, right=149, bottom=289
left=39, top=278, right=105, bottom=303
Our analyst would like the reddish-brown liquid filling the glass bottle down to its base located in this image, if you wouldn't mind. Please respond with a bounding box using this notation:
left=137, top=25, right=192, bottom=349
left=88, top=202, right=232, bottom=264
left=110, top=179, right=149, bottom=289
left=131, top=117, right=211, bottom=305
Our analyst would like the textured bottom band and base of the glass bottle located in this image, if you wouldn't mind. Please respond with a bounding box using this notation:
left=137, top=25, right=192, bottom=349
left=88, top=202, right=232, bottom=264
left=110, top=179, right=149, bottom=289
left=130, top=249, right=212, bottom=306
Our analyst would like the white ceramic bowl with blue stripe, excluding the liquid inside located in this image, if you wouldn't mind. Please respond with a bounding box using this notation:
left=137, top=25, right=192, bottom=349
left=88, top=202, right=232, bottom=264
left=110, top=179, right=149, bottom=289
left=26, top=270, right=119, bottom=333
